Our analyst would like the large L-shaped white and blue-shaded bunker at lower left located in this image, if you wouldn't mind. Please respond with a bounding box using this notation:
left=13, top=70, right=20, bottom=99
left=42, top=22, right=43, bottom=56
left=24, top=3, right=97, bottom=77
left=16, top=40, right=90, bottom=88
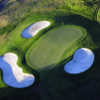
left=0, top=53, right=35, bottom=88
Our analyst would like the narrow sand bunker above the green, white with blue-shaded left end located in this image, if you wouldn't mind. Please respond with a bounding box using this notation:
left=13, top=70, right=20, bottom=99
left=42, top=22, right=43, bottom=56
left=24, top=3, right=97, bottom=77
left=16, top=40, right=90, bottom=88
left=22, top=21, right=51, bottom=38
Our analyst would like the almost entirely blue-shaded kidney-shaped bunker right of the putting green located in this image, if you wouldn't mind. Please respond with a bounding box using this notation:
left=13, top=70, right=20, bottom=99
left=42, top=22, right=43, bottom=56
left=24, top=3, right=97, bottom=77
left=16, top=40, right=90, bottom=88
left=64, top=48, right=94, bottom=74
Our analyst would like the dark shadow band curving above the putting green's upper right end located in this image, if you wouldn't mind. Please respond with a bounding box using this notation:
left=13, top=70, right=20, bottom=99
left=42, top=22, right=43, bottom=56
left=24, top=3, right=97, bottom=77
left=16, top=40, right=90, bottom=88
left=54, top=15, right=100, bottom=45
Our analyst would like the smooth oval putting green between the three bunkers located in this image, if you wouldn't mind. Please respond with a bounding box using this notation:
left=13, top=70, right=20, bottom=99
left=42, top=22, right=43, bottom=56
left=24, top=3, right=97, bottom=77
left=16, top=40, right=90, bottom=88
left=26, top=25, right=86, bottom=69
